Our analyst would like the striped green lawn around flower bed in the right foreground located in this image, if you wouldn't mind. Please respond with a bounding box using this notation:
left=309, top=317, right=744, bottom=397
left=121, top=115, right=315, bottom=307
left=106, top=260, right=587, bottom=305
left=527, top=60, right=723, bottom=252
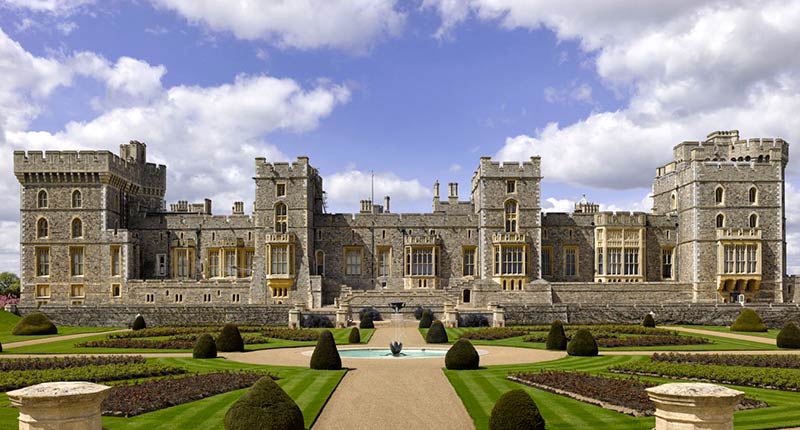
left=444, top=356, right=800, bottom=429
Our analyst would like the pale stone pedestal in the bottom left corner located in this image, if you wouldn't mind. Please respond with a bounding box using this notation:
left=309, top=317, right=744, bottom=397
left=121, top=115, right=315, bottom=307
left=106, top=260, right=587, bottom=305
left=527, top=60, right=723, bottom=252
left=8, top=382, right=111, bottom=430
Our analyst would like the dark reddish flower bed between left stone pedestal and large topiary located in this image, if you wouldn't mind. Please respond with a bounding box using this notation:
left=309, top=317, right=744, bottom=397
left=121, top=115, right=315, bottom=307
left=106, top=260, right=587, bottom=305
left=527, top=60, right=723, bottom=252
left=103, top=372, right=274, bottom=417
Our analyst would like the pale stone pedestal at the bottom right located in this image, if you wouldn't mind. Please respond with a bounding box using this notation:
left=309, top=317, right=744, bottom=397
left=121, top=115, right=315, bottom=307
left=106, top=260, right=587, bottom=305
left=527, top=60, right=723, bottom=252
left=647, top=383, right=744, bottom=430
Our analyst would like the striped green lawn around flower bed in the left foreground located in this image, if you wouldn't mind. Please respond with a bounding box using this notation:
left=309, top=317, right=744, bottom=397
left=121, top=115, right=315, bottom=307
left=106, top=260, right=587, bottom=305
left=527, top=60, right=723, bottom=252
left=0, top=358, right=345, bottom=430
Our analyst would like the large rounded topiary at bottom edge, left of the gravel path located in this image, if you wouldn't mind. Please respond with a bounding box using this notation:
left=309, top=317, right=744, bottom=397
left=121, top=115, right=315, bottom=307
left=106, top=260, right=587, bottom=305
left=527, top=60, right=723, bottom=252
left=225, top=376, right=305, bottom=430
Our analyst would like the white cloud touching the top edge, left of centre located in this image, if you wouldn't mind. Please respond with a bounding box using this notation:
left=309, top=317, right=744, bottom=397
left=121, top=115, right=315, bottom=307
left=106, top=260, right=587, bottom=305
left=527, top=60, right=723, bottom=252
left=152, top=0, right=406, bottom=51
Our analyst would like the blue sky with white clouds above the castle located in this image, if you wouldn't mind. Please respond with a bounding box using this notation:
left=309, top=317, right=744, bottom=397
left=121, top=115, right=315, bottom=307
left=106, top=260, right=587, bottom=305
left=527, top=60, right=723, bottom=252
left=0, top=0, right=800, bottom=273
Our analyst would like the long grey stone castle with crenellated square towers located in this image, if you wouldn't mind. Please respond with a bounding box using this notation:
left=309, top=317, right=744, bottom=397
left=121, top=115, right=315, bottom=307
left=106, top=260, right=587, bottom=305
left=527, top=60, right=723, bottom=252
left=14, top=130, right=795, bottom=309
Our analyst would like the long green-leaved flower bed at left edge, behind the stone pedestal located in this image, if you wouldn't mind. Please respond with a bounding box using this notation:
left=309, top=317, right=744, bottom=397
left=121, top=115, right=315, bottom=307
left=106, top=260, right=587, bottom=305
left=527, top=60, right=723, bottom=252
left=0, top=363, right=186, bottom=391
